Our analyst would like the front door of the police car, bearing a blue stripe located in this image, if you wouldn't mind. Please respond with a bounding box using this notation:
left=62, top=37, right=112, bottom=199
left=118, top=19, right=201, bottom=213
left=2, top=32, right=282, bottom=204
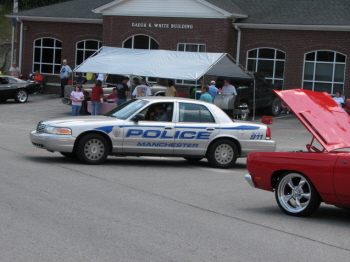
left=123, top=102, right=175, bottom=155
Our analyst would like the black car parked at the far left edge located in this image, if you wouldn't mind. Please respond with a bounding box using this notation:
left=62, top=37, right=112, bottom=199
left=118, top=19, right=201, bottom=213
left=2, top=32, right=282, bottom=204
left=0, top=75, right=39, bottom=103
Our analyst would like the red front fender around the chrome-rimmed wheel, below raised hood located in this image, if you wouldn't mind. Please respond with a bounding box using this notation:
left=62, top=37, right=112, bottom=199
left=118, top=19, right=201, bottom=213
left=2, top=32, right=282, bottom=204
left=247, top=152, right=339, bottom=205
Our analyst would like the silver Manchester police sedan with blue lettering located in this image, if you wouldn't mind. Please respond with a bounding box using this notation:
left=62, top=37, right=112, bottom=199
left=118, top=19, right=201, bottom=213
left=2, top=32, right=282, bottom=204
left=30, top=97, right=276, bottom=168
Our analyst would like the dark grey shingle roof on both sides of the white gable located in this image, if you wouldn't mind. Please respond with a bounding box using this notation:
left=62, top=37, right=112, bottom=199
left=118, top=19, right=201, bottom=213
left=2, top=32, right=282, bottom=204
left=8, top=0, right=350, bottom=26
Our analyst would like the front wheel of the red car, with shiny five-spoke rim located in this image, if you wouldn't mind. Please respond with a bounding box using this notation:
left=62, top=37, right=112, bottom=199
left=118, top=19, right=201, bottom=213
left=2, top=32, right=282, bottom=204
left=275, top=172, right=321, bottom=217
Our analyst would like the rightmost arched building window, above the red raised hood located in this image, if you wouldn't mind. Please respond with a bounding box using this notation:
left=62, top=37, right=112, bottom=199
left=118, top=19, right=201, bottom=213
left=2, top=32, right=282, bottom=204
left=303, top=51, right=346, bottom=94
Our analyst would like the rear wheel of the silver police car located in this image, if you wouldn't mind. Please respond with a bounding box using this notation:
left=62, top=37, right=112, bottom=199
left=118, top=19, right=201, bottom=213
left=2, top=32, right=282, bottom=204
left=207, top=139, right=238, bottom=168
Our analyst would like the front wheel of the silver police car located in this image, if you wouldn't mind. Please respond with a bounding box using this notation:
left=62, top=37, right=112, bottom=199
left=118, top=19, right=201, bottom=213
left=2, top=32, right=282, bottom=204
left=76, top=134, right=109, bottom=165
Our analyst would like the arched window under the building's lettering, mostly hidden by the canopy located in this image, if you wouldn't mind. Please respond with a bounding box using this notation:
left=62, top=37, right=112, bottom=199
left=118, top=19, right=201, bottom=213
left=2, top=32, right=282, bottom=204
left=123, top=35, right=159, bottom=83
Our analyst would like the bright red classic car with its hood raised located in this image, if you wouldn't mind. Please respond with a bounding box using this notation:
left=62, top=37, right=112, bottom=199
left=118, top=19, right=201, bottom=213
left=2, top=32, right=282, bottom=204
left=245, top=89, right=350, bottom=216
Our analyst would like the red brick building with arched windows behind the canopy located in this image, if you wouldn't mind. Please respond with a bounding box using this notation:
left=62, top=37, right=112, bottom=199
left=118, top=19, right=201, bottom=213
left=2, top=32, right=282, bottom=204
left=8, top=0, right=350, bottom=96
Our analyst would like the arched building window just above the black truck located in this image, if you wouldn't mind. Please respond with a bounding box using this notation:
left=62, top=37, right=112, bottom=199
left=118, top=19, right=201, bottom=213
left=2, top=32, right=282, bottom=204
left=247, top=48, right=286, bottom=86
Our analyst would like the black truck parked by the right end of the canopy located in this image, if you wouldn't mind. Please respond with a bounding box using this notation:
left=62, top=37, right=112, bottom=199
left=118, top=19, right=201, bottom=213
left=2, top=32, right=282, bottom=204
left=216, top=73, right=281, bottom=120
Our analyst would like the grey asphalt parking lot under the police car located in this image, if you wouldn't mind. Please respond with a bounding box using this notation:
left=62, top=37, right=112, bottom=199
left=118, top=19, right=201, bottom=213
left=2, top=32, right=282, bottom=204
left=0, top=95, right=350, bottom=262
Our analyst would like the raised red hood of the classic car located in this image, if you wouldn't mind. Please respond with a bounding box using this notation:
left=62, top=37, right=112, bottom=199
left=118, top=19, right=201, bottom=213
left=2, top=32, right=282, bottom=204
left=274, top=89, right=350, bottom=152
